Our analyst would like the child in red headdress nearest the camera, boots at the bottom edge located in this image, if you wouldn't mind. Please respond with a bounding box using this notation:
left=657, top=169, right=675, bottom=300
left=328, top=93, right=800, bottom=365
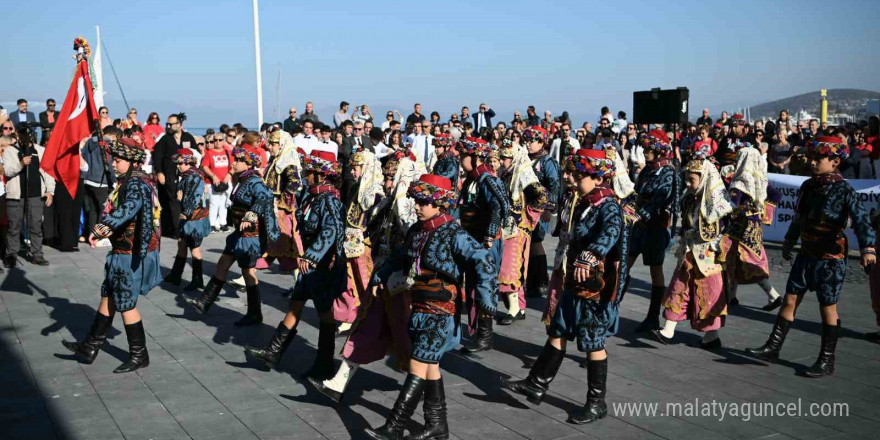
left=366, top=174, right=498, bottom=439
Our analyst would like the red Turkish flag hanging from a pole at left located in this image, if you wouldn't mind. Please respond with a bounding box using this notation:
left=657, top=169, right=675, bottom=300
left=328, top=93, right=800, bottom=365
left=40, top=60, right=98, bottom=197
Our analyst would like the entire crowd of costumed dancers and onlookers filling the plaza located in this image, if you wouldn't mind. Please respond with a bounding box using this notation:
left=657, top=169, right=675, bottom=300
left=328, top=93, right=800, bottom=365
left=0, top=94, right=880, bottom=439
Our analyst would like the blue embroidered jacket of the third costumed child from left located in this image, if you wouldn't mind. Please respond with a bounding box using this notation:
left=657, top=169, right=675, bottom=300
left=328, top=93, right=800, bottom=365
left=231, top=174, right=281, bottom=254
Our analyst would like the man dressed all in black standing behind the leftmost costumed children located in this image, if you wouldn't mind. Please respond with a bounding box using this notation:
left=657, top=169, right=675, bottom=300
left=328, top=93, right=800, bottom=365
left=153, top=114, right=196, bottom=238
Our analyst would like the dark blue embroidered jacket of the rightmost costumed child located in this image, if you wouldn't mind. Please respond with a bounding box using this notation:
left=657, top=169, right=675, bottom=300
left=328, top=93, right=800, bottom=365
left=785, top=174, right=876, bottom=260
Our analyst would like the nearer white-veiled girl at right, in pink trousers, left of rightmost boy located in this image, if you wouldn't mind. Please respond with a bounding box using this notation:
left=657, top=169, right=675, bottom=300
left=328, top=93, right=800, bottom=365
left=652, top=153, right=733, bottom=349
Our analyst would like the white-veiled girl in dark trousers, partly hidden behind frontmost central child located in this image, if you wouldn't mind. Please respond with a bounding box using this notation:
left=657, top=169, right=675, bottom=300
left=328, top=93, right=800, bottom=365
left=309, top=151, right=423, bottom=403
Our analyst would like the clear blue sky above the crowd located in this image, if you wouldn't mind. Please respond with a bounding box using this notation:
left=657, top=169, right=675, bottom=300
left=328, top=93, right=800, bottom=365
left=0, top=0, right=880, bottom=127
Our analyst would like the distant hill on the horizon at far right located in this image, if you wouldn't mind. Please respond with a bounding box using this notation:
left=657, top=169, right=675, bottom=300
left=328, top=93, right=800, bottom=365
left=732, top=89, right=880, bottom=120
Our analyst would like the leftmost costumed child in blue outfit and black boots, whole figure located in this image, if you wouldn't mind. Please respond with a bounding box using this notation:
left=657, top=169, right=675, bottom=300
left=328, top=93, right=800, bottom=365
left=63, top=139, right=162, bottom=373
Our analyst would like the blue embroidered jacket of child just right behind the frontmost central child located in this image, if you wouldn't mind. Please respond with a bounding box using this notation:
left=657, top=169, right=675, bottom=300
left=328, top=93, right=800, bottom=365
left=459, top=172, right=510, bottom=242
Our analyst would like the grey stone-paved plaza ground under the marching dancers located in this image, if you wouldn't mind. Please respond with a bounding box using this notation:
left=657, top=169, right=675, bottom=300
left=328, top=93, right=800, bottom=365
left=0, top=234, right=880, bottom=440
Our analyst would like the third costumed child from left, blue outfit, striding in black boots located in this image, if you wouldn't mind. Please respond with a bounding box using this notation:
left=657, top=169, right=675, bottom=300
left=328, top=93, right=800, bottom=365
left=186, top=144, right=280, bottom=326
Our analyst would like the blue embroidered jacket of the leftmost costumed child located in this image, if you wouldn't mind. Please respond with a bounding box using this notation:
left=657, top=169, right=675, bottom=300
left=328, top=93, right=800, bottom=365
left=94, top=170, right=161, bottom=257
